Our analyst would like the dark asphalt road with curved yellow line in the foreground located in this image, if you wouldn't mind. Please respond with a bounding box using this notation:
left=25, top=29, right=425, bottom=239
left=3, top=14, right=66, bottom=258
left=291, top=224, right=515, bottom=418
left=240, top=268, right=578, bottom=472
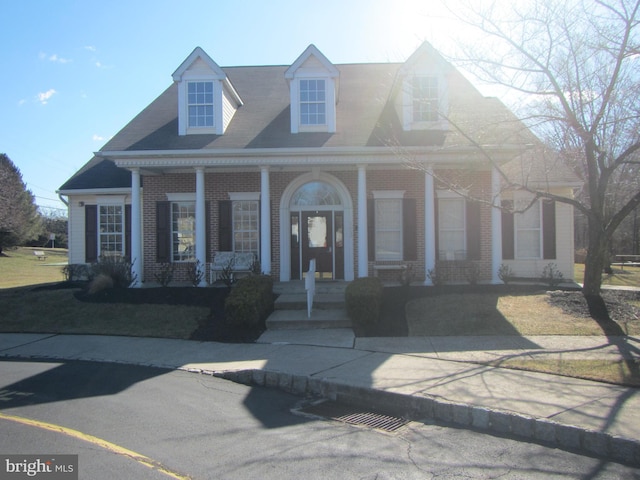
left=0, top=361, right=640, bottom=480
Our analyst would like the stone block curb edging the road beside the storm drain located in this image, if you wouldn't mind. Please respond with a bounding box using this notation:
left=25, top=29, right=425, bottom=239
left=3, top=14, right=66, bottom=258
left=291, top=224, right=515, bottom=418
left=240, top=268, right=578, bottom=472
left=195, top=369, right=640, bottom=466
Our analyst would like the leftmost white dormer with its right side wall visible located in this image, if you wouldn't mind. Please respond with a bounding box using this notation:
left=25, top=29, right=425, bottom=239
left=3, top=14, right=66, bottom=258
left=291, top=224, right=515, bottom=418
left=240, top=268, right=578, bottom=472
left=173, top=47, right=242, bottom=135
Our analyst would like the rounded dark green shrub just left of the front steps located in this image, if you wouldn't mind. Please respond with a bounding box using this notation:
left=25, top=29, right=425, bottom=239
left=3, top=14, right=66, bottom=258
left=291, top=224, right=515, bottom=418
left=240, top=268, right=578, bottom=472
left=224, top=275, right=273, bottom=328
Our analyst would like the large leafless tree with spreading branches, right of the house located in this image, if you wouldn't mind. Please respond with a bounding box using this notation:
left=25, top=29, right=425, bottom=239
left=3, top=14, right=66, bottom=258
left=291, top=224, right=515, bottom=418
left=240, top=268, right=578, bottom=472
left=442, top=0, right=640, bottom=299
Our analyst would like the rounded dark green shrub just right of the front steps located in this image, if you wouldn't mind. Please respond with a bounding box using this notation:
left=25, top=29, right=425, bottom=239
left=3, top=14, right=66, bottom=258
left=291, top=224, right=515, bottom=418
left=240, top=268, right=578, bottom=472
left=344, top=277, right=384, bottom=325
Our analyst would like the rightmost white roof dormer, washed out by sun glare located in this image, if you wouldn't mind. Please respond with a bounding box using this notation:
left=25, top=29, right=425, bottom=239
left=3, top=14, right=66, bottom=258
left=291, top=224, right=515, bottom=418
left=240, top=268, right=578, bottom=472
left=396, top=42, right=450, bottom=131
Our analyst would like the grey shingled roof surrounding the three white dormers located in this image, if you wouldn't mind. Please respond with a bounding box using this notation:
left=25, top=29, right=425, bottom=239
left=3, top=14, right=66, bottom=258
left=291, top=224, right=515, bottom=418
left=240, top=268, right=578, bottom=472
left=61, top=44, right=538, bottom=190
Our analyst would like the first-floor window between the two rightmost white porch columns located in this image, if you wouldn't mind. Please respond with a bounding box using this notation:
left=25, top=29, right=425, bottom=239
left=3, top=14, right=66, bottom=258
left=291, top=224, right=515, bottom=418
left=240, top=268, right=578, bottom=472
left=438, top=197, right=467, bottom=260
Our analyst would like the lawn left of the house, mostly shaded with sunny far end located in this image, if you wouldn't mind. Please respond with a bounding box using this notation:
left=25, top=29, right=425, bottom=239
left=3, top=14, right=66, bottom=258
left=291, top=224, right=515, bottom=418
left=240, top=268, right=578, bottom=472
left=0, top=247, right=209, bottom=339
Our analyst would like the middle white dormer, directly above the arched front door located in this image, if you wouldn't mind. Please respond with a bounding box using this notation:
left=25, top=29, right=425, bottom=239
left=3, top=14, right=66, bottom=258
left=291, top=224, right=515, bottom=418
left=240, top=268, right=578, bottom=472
left=284, top=45, right=340, bottom=133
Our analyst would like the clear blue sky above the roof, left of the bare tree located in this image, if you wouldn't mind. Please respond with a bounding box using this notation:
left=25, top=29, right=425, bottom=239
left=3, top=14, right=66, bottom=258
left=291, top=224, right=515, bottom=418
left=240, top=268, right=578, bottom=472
left=0, top=0, right=480, bottom=214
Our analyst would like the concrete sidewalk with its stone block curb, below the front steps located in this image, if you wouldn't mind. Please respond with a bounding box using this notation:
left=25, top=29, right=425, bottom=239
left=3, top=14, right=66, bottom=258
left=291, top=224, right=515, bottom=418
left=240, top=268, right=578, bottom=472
left=0, top=329, right=640, bottom=465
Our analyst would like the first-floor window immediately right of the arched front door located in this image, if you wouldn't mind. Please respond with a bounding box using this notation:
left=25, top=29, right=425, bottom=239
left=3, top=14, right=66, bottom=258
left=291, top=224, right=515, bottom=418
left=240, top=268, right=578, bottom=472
left=375, top=198, right=402, bottom=260
